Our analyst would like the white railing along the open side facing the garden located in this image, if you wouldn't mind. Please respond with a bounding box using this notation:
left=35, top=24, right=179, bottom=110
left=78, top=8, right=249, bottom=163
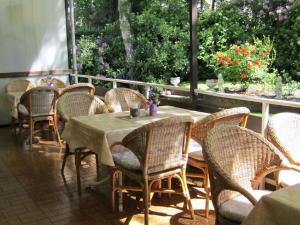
left=71, top=74, right=300, bottom=135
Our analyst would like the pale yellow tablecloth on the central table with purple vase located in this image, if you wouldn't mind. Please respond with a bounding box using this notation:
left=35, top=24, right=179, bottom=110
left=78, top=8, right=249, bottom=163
left=62, top=106, right=208, bottom=166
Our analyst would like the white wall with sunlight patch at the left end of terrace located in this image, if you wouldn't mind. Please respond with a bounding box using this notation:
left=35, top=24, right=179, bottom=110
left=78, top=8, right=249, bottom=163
left=0, top=0, right=68, bottom=125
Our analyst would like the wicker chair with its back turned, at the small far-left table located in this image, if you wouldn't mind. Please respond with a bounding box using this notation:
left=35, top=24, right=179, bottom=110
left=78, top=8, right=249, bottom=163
left=17, top=87, right=61, bottom=150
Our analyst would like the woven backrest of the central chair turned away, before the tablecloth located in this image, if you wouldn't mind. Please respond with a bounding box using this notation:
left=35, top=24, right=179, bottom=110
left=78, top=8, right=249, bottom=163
left=122, top=116, right=192, bottom=176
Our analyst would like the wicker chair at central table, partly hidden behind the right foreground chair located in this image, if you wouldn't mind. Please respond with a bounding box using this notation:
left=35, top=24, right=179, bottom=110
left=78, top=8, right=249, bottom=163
left=187, top=107, right=250, bottom=218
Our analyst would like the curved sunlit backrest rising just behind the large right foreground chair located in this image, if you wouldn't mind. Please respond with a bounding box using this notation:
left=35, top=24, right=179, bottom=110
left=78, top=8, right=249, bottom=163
left=192, top=107, right=250, bottom=145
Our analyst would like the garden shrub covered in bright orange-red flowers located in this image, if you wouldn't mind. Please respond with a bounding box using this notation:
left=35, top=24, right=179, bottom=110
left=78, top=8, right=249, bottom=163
left=210, top=38, right=274, bottom=83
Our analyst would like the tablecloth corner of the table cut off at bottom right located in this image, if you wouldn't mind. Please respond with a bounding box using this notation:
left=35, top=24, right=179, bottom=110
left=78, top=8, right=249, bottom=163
left=242, top=184, right=300, bottom=225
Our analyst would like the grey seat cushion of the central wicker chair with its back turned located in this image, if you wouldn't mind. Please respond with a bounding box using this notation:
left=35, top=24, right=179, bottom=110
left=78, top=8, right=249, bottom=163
left=112, top=146, right=141, bottom=170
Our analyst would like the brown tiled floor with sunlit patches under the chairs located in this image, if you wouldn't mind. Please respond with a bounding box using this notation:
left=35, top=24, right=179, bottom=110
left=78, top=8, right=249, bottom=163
left=0, top=127, right=214, bottom=225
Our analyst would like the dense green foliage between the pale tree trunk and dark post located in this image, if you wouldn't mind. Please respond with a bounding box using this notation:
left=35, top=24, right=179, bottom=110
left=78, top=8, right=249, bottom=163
left=131, top=0, right=189, bottom=83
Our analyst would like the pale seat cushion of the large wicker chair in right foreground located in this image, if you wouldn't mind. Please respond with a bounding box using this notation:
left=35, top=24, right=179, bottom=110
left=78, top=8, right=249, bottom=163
left=219, top=190, right=271, bottom=223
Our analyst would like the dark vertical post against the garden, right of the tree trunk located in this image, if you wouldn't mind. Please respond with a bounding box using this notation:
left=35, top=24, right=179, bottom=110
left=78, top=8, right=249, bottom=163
left=189, top=0, right=198, bottom=102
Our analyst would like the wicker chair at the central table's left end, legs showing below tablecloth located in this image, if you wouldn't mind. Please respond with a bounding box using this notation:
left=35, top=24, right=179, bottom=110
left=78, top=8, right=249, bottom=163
left=57, top=92, right=108, bottom=193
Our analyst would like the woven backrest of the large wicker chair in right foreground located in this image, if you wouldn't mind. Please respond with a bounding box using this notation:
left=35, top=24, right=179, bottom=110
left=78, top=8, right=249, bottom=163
left=203, top=125, right=282, bottom=207
